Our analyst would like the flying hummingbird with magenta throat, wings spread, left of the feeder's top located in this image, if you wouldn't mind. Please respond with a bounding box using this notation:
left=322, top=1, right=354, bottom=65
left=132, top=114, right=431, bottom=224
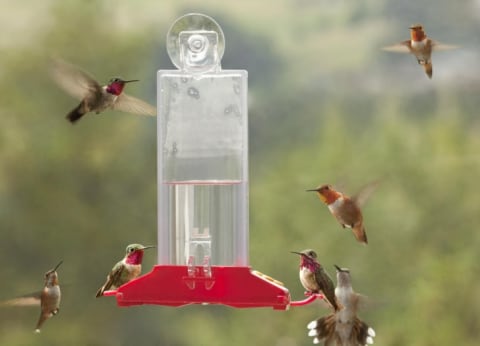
left=51, top=59, right=157, bottom=123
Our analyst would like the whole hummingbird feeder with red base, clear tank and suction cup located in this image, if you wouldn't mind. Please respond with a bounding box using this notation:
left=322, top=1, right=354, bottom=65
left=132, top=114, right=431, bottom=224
left=105, top=14, right=317, bottom=310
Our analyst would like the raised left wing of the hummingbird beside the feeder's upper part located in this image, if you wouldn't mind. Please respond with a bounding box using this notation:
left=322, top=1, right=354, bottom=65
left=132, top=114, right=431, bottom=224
left=50, top=59, right=102, bottom=100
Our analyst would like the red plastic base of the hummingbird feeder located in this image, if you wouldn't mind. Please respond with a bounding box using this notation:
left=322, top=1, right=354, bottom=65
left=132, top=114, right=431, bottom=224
left=104, top=265, right=290, bottom=310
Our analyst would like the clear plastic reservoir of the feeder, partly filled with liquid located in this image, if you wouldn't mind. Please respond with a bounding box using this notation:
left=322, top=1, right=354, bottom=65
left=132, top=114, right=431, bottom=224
left=158, top=49, right=248, bottom=265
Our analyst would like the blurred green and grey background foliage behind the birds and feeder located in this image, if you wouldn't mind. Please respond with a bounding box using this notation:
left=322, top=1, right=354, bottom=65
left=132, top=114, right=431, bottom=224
left=0, top=0, right=480, bottom=346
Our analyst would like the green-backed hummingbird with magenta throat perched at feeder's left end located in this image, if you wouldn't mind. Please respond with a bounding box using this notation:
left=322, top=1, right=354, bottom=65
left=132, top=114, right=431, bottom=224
left=96, top=244, right=155, bottom=298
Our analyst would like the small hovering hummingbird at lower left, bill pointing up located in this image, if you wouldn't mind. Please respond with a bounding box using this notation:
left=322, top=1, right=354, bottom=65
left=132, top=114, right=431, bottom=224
left=1, top=261, right=63, bottom=333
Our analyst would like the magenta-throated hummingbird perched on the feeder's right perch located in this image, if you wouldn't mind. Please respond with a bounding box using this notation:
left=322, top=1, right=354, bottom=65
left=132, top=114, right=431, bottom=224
left=292, top=249, right=340, bottom=311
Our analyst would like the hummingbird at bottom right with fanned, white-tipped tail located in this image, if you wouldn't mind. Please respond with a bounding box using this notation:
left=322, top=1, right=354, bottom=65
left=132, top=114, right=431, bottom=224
left=307, top=266, right=375, bottom=346
